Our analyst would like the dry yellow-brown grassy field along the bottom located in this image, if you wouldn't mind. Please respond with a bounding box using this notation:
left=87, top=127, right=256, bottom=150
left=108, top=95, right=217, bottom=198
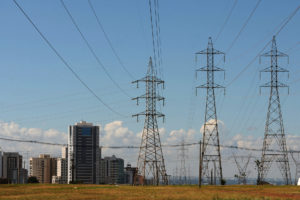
left=0, top=184, right=300, bottom=200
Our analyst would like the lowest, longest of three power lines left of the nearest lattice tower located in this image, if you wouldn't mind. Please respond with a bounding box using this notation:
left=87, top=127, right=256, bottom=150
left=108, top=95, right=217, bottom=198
left=13, top=0, right=125, bottom=117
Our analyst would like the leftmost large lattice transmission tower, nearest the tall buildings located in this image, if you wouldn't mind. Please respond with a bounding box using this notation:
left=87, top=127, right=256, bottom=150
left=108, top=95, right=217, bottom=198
left=132, top=57, right=168, bottom=185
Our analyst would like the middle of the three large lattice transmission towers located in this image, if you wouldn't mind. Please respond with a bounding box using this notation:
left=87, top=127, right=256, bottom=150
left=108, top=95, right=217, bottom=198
left=196, top=37, right=225, bottom=185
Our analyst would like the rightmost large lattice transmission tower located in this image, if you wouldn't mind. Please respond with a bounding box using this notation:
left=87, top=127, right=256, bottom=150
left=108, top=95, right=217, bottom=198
left=259, top=36, right=291, bottom=185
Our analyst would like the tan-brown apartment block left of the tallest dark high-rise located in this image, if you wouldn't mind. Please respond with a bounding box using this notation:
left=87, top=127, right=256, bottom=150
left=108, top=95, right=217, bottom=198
left=30, top=154, right=57, bottom=183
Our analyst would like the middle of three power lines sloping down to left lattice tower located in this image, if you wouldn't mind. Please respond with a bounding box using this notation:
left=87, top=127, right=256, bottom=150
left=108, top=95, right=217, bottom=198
left=60, top=0, right=131, bottom=98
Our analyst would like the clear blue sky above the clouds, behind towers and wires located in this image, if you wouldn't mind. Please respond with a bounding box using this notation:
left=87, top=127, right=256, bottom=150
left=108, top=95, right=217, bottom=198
left=0, top=0, right=300, bottom=178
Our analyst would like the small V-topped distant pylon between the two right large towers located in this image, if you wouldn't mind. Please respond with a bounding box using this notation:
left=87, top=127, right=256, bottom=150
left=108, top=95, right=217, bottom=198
left=233, top=154, right=252, bottom=185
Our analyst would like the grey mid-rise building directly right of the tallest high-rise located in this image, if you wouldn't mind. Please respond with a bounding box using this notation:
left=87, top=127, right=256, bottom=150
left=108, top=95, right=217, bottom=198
left=100, top=155, right=124, bottom=184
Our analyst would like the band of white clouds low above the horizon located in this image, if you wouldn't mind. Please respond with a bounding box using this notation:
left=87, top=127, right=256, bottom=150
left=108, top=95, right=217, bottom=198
left=0, top=120, right=300, bottom=180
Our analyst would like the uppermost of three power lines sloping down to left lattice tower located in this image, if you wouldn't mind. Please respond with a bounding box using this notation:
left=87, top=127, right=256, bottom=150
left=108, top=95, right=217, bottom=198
left=88, top=0, right=135, bottom=79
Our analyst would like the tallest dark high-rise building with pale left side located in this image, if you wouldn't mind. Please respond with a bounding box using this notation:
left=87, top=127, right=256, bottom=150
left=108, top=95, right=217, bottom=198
left=68, top=121, right=100, bottom=184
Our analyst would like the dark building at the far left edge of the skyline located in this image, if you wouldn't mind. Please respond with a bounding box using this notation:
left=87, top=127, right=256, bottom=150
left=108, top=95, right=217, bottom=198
left=2, top=152, right=27, bottom=183
